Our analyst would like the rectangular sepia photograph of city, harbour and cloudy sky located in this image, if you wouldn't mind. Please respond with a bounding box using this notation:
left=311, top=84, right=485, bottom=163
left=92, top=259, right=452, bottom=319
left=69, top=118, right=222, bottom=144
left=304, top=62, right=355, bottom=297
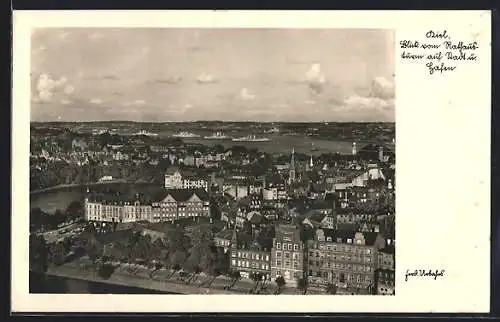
left=29, top=28, right=396, bottom=295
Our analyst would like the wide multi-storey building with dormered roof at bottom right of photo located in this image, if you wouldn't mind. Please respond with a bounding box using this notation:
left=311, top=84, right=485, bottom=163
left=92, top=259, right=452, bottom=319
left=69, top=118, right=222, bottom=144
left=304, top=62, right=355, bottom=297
left=307, top=229, right=385, bottom=294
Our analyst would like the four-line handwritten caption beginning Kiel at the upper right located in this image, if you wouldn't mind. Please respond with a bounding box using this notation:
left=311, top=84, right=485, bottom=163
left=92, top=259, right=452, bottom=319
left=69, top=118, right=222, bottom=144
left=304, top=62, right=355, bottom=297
left=399, top=30, right=479, bottom=75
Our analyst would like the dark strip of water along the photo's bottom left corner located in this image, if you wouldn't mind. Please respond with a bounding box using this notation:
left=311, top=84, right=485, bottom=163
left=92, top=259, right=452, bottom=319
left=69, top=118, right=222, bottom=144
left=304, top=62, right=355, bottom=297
left=30, top=273, right=176, bottom=294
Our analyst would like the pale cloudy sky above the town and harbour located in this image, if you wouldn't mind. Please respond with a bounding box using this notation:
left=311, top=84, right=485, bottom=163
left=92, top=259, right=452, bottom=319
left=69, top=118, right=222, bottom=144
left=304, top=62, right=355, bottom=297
left=31, top=28, right=395, bottom=122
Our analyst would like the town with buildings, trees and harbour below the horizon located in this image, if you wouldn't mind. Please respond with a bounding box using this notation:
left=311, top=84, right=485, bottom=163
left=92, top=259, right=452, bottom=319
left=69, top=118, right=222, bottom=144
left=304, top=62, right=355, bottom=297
left=30, top=121, right=396, bottom=295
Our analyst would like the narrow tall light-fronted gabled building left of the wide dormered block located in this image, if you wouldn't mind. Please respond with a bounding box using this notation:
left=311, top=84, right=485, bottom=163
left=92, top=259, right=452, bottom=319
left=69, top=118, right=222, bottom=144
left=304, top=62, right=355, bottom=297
left=271, top=224, right=304, bottom=286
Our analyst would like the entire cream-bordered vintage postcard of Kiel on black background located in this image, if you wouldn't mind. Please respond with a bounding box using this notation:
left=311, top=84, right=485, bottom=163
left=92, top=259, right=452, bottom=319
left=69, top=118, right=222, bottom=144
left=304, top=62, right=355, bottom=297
left=11, top=11, right=491, bottom=313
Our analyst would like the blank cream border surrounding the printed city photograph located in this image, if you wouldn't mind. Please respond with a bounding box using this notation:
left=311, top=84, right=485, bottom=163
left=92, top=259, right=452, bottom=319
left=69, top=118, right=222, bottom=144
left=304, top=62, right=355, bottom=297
left=12, top=11, right=491, bottom=312
